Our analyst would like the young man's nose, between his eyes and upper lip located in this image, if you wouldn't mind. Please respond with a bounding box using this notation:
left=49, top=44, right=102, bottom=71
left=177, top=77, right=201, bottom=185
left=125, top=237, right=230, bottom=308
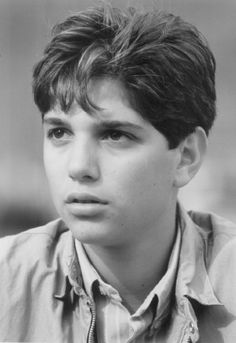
left=68, top=139, right=100, bottom=183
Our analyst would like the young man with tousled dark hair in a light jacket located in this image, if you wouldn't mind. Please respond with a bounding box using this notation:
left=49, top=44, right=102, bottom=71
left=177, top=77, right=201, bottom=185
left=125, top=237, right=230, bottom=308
left=0, top=6, right=236, bottom=343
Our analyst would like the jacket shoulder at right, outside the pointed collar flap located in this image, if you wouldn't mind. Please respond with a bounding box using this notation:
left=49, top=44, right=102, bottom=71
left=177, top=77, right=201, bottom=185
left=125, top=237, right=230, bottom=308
left=190, top=212, right=236, bottom=315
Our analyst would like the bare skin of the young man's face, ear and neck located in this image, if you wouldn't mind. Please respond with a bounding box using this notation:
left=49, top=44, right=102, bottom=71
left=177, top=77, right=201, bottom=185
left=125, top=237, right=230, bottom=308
left=44, top=78, right=206, bottom=310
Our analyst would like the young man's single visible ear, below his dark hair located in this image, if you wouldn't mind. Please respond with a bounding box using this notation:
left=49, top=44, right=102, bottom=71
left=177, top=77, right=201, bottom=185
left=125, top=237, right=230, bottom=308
left=174, top=127, right=208, bottom=188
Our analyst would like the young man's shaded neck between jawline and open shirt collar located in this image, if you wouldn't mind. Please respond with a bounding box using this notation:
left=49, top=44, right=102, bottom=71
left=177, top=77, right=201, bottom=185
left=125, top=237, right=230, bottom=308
left=84, top=206, right=176, bottom=312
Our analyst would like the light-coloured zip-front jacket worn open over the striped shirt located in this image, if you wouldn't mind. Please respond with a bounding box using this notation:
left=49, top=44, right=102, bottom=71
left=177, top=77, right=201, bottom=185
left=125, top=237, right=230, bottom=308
left=0, top=209, right=236, bottom=343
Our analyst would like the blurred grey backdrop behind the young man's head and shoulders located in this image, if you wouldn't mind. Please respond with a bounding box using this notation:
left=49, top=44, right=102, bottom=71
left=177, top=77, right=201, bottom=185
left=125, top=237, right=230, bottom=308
left=0, top=0, right=236, bottom=236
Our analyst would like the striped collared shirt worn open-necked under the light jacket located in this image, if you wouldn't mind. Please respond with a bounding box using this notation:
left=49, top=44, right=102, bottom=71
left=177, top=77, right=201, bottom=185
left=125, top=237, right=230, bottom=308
left=76, top=227, right=181, bottom=343
